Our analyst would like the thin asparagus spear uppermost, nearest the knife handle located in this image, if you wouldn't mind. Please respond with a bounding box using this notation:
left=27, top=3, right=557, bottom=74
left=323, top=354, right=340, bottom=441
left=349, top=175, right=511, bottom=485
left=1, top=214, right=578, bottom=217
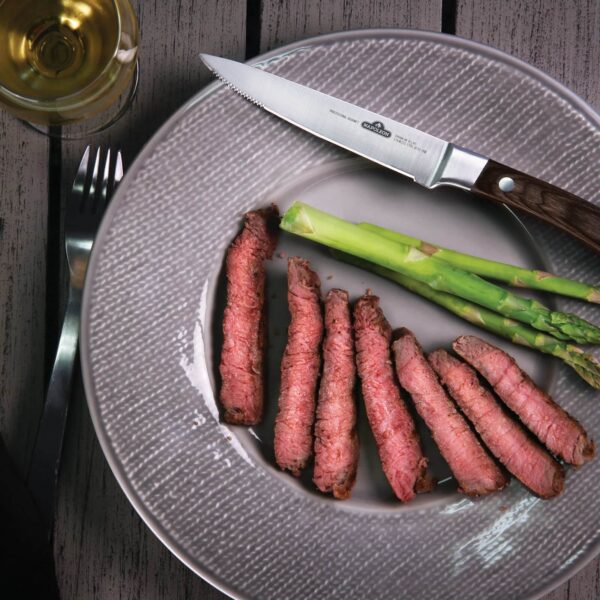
left=359, top=223, right=600, bottom=304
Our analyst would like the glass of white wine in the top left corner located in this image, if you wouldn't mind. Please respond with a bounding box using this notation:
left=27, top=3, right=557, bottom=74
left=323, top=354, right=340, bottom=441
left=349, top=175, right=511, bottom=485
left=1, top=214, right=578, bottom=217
left=0, top=0, right=138, bottom=125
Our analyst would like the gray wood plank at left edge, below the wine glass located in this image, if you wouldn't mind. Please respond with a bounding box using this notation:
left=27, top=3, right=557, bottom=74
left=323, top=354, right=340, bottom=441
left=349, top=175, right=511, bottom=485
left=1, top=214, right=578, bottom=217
left=0, top=115, right=48, bottom=477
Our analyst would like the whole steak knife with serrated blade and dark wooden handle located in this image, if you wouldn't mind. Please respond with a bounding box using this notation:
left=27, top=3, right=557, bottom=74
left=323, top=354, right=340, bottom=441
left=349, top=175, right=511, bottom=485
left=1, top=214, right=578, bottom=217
left=200, top=54, right=600, bottom=253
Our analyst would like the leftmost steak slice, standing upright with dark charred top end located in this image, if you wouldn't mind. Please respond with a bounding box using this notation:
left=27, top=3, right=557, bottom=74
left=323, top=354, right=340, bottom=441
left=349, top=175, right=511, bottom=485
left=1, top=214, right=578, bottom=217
left=219, top=205, right=279, bottom=425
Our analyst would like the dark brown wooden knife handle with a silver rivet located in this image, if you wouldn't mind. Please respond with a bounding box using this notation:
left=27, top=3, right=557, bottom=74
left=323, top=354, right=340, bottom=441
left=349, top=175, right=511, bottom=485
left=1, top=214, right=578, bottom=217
left=471, top=160, right=600, bottom=254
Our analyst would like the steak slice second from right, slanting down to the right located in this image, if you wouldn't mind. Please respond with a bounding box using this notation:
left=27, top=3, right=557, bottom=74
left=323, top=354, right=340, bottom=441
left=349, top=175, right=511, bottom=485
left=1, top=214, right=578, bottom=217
left=428, top=349, right=565, bottom=498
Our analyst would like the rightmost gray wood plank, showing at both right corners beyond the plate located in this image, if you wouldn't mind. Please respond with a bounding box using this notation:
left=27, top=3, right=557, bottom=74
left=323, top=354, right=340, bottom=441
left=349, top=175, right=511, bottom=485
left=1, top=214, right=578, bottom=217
left=456, top=0, right=600, bottom=600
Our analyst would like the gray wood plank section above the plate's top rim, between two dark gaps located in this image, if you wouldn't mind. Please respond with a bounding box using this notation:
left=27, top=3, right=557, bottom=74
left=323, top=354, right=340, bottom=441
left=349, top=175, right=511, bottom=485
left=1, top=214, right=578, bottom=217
left=260, top=0, right=442, bottom=52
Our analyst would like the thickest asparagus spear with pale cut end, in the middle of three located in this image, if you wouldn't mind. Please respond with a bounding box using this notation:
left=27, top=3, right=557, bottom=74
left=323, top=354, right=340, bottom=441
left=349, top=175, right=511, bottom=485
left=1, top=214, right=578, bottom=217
left=280, top=202, right=600, bottom=343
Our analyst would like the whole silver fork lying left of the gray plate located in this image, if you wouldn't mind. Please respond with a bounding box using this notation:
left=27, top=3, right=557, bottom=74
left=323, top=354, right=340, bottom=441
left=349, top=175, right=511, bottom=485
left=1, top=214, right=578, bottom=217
left=27, top=146, right=123, bottom=538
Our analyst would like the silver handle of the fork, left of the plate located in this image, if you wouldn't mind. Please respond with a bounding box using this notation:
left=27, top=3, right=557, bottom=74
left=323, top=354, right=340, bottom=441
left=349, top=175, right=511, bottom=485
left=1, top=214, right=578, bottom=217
left=27, top=286, right=81, bottom=539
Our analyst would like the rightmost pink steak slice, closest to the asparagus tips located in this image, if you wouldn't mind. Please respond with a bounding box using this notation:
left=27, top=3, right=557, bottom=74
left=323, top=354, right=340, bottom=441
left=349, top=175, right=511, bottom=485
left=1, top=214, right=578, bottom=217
left=452, top=335, right=595, bottom=465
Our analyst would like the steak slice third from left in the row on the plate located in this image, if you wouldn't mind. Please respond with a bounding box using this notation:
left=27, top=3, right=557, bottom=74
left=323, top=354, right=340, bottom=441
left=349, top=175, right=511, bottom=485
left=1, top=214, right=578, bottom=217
left=313, top=289, right=358, bottom=500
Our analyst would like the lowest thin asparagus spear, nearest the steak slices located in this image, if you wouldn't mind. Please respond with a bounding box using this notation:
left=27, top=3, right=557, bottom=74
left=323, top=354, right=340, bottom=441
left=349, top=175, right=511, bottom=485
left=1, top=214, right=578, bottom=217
left=333, top=250, right=600, bottom=389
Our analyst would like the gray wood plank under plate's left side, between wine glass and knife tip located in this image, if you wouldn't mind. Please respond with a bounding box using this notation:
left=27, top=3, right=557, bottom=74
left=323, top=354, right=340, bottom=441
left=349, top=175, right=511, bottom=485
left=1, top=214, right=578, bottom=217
left=55, top=0, right=246, bottom=600
